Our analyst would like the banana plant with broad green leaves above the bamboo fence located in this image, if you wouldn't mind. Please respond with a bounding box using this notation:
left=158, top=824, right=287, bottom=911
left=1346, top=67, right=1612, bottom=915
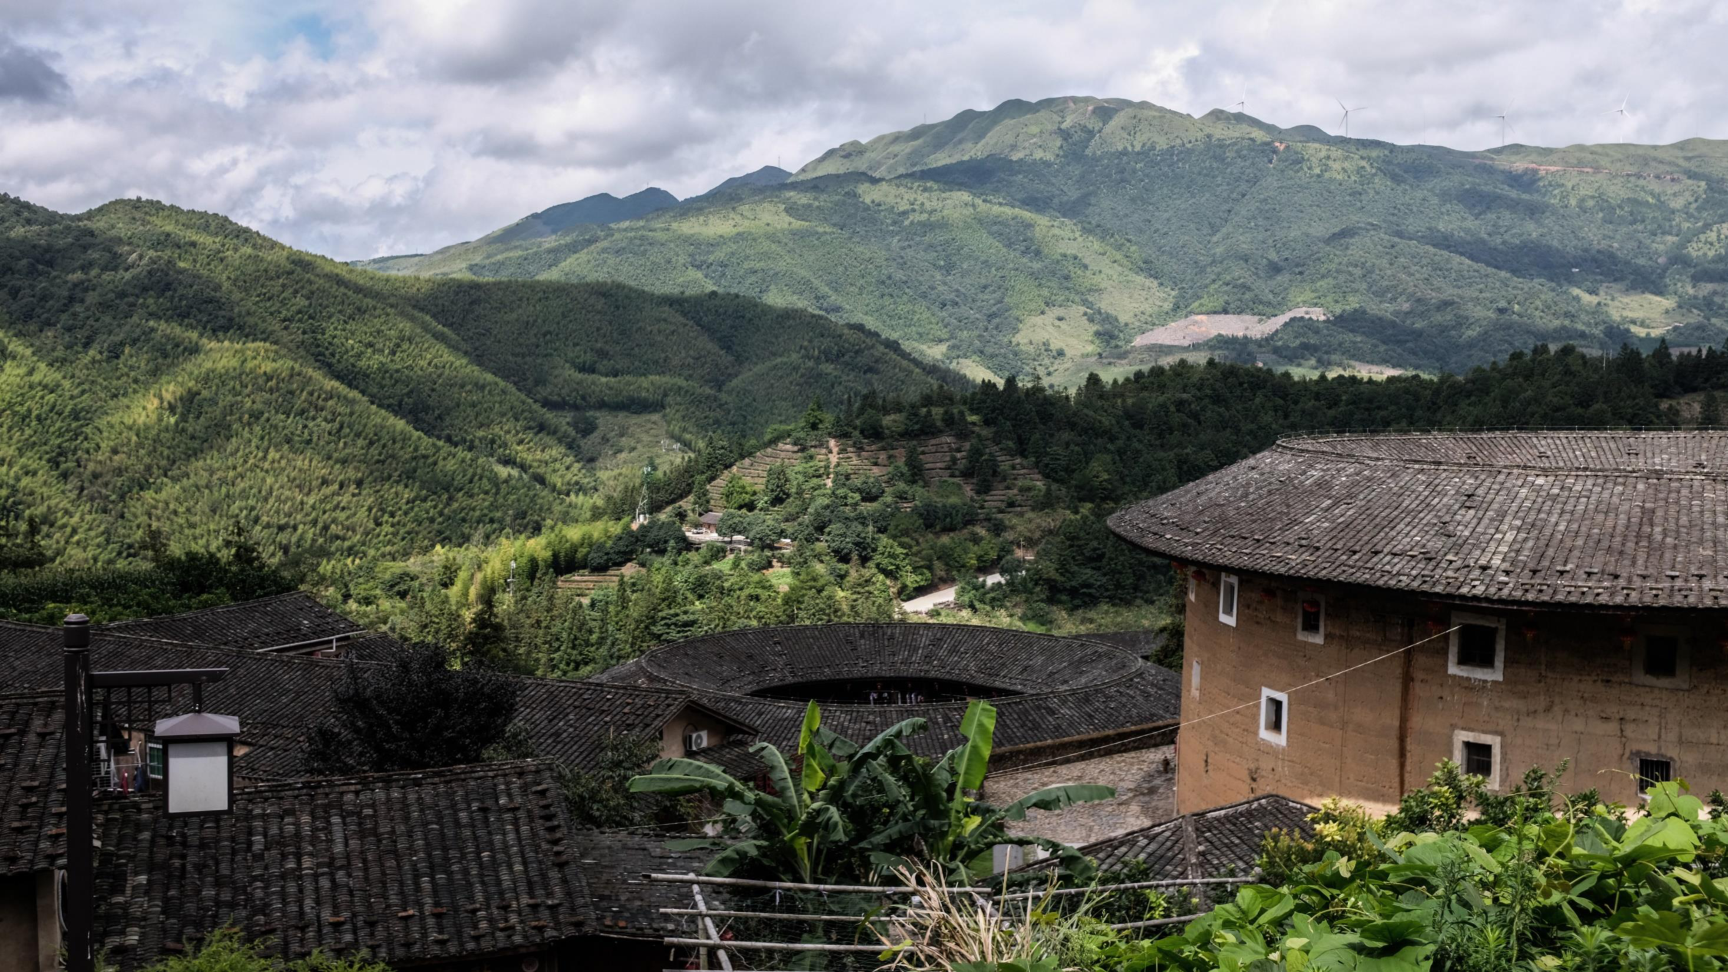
left=631, top=700, right=1116, bottom=882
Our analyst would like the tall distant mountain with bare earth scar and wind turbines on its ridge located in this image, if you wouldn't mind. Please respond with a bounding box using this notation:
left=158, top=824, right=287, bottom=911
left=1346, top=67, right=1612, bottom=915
left=361, top=97, right=1728, bottom=384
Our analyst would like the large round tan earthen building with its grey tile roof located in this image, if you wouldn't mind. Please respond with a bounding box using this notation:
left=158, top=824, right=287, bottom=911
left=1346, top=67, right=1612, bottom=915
left=1109, top=431, right=1728, bottom=813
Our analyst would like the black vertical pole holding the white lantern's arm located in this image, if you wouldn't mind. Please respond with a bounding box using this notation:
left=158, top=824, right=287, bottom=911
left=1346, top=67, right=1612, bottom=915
left=60, top=614, right=97, bottom=972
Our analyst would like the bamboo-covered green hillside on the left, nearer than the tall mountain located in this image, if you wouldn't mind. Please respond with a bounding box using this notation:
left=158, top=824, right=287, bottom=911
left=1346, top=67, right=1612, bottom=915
left=0, top=195, right=959, bottom=564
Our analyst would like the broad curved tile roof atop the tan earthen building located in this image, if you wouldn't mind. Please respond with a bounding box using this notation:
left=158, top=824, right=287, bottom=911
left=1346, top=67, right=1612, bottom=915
left=1109, top=431, right=1728, bottom=607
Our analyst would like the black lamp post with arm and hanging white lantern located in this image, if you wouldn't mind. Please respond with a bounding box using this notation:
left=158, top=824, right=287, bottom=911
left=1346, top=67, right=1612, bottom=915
left=60, top=614, right=240, bottom=972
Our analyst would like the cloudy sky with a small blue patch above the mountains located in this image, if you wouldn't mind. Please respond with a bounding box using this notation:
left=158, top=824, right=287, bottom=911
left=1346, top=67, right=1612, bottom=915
left=0, top=0, right=1728, bottom=258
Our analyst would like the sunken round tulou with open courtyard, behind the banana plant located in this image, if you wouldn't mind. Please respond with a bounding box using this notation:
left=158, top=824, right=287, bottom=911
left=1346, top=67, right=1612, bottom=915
left=596, top=624, right=1182, bottom=842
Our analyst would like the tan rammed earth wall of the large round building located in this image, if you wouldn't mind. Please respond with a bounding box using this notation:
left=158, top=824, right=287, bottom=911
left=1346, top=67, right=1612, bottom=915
left=1177, top=566, right=1728, bottom=813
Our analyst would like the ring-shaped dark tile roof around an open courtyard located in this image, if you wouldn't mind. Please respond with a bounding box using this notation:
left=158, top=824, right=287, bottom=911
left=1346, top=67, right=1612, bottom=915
left=596, top=624, right=1182, bottom=754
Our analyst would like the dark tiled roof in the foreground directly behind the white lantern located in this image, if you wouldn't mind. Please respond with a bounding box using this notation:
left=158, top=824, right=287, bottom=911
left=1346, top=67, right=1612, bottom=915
left=95, top=761, right=594, bottom=969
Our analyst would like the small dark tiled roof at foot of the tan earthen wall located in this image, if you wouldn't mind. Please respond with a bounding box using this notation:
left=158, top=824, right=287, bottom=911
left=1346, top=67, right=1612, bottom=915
left=1029, top=794, right=1315, bottom=880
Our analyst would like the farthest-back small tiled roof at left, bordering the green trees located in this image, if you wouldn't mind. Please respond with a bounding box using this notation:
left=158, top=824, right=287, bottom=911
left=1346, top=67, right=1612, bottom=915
left=98, top=592, right=366, bottom=650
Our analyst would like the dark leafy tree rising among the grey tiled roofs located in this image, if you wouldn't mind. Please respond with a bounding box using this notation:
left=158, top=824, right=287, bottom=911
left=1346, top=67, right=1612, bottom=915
left=302, top=645, right=525, bottom=777
